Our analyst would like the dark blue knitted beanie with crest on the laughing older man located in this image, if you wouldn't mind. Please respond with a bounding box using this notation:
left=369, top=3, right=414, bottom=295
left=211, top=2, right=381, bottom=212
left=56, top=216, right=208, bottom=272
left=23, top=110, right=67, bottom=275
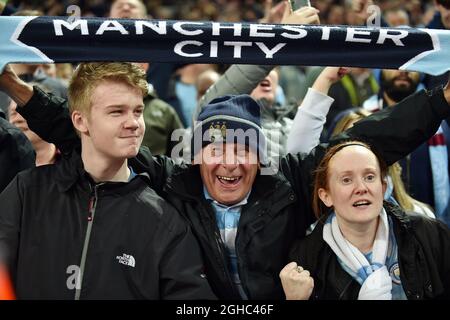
left=191, top=94, right=267, bottom=164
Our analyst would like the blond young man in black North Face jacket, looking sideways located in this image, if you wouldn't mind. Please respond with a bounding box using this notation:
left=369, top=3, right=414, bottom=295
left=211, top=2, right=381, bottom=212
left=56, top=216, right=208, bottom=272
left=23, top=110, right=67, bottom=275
left=0, top=63, right=214, bottom=299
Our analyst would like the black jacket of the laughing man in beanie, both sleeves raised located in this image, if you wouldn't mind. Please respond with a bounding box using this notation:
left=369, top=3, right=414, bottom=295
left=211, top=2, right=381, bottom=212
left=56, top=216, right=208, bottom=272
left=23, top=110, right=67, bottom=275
left=19, top=85, right=450, bottom=299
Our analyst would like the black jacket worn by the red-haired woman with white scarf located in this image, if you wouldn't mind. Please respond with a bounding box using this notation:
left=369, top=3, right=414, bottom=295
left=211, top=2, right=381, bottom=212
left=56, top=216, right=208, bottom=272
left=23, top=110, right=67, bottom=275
left=290, top=202, right=450, bottom=300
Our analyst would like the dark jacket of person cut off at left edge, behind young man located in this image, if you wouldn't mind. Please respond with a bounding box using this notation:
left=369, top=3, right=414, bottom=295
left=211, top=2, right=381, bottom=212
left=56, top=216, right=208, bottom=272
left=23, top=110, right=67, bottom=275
left=0, top=115, right=36, bottom=192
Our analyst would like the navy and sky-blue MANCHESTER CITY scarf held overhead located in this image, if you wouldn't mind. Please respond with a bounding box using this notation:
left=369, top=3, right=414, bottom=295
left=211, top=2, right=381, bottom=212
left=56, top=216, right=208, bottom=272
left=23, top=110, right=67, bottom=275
left=0, top=17, right=450, bottom=75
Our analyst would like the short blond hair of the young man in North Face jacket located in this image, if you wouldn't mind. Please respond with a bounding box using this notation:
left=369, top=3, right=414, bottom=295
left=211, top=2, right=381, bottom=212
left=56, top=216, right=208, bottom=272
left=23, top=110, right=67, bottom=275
left=67, top=62, right=148, bottom=116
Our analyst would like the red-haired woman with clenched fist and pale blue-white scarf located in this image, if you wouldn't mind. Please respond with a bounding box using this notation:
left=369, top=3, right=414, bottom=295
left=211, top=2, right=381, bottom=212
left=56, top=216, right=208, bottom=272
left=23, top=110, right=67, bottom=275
left=280, top=141, right=450, bottom=300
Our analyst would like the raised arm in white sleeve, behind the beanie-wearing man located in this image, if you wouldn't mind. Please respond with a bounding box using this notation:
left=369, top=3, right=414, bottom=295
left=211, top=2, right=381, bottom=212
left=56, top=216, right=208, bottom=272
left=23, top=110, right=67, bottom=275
left=287, top=67, right=348, bottom=154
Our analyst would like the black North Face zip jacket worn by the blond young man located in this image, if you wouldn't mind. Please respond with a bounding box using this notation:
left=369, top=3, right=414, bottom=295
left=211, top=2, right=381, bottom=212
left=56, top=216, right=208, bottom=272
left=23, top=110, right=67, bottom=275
left=0, top=153, right=214, bottom=299
